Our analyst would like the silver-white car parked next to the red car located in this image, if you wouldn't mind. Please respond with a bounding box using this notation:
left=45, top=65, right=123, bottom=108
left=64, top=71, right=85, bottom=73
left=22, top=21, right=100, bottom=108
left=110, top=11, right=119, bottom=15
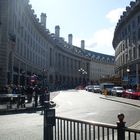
left=111, top=86, right=124, bottom=97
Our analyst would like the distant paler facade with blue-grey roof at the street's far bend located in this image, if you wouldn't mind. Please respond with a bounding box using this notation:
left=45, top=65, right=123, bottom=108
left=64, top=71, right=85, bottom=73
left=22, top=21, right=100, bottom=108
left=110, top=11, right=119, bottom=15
left=90, top=52, right=115, bottom=83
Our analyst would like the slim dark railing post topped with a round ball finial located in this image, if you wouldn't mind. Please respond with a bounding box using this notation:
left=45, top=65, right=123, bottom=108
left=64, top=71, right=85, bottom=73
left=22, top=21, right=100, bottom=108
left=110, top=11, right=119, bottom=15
left=117, top=113, right=125, bottom=140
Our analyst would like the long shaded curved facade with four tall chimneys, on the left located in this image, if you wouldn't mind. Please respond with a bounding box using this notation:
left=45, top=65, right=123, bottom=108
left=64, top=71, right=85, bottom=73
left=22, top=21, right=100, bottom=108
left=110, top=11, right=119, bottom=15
left=0, top=0, right=115, bottom=88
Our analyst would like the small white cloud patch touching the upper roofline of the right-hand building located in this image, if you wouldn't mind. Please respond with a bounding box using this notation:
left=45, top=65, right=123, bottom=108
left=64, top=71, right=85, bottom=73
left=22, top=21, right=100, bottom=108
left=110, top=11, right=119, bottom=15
left=106, top=8, right=125, bottom=23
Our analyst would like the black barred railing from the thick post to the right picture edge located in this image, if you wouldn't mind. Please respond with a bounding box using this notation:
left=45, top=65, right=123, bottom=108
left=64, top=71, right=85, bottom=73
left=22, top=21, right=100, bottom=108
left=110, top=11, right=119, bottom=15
left=53, top=117, right=140, bottom=140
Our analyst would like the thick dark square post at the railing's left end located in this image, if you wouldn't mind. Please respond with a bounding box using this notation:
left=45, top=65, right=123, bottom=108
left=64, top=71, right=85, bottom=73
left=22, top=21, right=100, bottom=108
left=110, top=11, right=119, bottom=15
left=44, top=101, right=55, bottom=140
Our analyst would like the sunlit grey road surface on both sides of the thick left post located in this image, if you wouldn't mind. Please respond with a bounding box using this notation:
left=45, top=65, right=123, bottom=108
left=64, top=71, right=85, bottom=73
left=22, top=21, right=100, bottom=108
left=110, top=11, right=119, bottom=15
left=0, top=90, right=140, bottom=140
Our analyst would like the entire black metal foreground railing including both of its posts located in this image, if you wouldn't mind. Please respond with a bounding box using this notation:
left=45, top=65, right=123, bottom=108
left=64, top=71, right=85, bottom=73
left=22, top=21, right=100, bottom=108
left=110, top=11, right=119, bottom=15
left=44, top=102, right=140, bottom=140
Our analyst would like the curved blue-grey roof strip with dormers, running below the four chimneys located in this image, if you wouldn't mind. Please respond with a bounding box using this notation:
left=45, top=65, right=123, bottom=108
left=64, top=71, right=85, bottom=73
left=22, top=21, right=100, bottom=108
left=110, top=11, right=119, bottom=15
left=23, top=0, right=114, bottom=63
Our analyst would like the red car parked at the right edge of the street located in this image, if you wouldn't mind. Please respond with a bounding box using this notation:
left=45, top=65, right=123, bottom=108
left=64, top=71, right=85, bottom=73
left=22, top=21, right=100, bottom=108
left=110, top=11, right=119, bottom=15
left=122, top=89, right=140, bottom=99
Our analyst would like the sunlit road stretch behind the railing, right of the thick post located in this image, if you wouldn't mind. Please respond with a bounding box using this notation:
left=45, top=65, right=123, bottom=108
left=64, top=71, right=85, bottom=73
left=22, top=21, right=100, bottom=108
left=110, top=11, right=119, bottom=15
left=54, top=90, right=140, bottom=127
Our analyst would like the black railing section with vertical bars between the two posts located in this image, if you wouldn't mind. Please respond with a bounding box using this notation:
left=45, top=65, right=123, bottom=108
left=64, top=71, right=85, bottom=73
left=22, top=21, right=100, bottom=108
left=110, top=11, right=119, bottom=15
left=54, top=117, right=117, bottom=140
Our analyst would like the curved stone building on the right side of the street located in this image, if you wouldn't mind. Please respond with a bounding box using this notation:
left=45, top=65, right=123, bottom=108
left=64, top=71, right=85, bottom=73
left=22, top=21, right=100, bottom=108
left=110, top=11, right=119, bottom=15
left=113, top=0, right=140, bottom=85
